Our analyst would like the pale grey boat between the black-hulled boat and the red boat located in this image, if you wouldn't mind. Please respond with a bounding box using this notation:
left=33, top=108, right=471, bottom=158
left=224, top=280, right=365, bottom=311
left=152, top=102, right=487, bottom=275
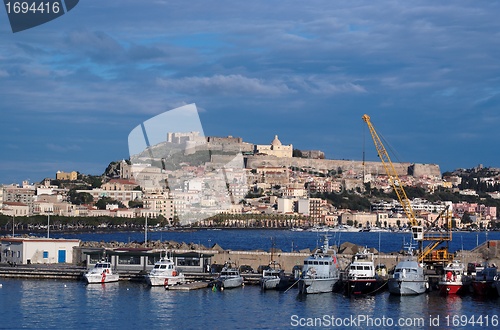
left=388, top=245, right=429, bottom=296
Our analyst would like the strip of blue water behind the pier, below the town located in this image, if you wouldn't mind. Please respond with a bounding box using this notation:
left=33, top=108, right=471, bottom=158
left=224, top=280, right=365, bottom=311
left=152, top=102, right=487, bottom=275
left=47, top=229, right=500, bottom=252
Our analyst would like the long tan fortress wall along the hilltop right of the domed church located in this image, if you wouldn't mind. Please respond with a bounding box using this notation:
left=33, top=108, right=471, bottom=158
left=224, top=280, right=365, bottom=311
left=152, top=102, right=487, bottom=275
left=245, top=155, right=441, bottom=177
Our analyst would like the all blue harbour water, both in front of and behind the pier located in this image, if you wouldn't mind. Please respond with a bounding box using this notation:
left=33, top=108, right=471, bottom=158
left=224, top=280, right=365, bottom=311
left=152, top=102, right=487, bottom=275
left=0, top=230, right=500, bottom=329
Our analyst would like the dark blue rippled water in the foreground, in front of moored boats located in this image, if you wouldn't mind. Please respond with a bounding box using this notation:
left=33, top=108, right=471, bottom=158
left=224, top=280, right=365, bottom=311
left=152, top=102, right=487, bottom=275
left=0, top=279, right=500, bottom=329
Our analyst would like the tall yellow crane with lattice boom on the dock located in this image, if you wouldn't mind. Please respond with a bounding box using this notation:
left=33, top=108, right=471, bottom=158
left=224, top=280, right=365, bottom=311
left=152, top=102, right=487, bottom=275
left=362, top=114, right=452, bottom=264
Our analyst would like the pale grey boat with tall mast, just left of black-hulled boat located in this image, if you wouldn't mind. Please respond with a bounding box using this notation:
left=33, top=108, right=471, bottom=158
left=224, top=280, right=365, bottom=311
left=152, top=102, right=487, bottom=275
left=298, top=236, right=340, bottom=294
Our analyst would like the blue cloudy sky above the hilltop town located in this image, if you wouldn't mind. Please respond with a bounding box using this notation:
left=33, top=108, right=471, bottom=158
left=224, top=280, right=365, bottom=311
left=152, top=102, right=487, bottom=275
left=0, top=0, right=500, bottom=184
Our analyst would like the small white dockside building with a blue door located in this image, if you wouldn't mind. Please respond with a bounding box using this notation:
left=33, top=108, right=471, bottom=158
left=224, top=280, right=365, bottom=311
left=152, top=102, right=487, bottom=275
left=0, top=237, right=80, bottom=265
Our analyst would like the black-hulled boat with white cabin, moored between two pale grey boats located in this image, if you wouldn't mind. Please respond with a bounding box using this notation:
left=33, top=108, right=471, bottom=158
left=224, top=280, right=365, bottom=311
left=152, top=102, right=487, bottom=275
left=346, top=249, right=387, bottom=296
